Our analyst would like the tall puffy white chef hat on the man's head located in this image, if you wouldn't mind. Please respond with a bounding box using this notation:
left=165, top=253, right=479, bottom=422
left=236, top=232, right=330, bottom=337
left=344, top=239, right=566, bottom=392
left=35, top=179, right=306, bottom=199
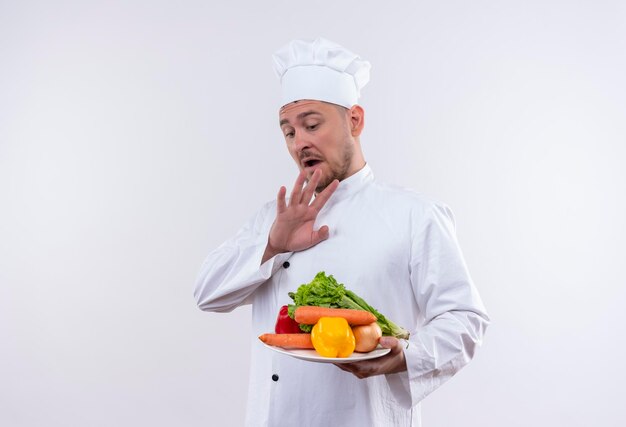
left=273, top=37, right=371, bottom=108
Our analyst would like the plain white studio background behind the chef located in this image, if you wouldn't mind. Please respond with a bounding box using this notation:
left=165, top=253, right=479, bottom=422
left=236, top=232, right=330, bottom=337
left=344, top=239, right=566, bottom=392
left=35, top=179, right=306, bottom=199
left=0, top=0, right=626, bottom=427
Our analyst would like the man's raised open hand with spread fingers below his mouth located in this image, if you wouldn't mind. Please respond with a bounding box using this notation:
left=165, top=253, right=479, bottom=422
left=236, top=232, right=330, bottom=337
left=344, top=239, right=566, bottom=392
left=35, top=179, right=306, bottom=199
left=262, top=169, right=339, bottom=262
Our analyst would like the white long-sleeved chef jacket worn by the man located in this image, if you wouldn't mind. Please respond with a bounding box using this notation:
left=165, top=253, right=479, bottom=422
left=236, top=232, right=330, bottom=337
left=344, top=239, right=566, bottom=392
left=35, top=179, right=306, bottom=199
left=195, top=165, right=488, bottom=427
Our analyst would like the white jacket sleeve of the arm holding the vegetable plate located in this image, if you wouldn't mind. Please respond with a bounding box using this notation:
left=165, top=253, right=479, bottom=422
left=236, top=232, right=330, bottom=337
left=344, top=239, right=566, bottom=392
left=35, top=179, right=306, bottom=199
left=387, top=205, right=489, bottom=408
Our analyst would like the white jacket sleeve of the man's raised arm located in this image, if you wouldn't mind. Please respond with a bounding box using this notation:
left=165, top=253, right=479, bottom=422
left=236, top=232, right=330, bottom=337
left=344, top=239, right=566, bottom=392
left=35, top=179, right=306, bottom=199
left=194, top=203, right=291, bottom=312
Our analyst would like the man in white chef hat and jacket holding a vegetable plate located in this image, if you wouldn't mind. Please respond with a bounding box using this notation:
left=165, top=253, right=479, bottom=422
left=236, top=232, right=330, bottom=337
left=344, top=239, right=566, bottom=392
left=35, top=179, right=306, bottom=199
left=195, top=38, right=489, bottom=426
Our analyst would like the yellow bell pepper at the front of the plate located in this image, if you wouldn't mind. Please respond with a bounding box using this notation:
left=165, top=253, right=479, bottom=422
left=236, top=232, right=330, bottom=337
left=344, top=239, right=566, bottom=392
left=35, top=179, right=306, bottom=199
left=311, top=317, right=356, bottom=357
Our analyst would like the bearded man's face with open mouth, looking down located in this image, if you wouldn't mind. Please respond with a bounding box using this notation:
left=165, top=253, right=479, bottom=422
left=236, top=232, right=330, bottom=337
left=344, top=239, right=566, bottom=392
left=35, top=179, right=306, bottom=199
left=279, top=100, right=362, bottom=192
